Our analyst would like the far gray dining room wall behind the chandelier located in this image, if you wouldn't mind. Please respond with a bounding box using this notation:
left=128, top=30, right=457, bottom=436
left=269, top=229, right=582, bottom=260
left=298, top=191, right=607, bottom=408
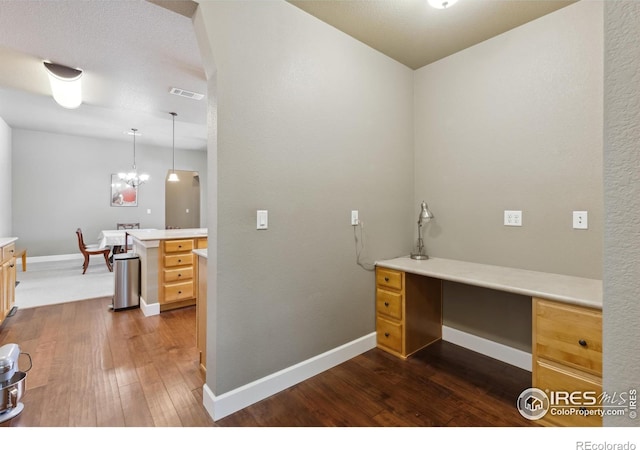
left=12, top=129, right=207, bottom=257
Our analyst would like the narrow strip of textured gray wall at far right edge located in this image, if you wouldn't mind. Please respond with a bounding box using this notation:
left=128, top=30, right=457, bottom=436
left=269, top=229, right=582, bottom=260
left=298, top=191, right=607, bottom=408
left=603, top=1, right=640, bottom=427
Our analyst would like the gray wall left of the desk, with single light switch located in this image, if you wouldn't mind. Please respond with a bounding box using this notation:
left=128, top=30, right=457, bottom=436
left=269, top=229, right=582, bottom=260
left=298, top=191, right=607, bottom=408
left=196, top=2, right=414, bottom=395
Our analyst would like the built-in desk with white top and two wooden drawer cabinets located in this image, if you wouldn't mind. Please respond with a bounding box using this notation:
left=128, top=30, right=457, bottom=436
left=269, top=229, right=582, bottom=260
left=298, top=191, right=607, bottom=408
left=376, top=257, right=602, bottom=426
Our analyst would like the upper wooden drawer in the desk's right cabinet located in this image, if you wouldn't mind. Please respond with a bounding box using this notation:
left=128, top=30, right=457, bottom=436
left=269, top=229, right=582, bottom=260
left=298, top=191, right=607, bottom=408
left=534, top=299, right=602, bottom=376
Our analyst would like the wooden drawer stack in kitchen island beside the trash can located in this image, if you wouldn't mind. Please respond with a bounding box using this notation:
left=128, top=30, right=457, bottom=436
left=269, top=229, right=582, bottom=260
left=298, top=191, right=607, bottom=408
left=158, top=238, right=207, bottom=311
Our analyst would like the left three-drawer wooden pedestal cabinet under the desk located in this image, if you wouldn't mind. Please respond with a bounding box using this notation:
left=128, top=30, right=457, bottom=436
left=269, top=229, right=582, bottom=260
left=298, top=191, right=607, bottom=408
left=376, top=267, right=442, bottom=358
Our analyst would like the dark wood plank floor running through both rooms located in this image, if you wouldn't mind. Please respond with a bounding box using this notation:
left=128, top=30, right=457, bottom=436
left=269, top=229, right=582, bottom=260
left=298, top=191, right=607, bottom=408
left=0, top=298, right=536, bottom=427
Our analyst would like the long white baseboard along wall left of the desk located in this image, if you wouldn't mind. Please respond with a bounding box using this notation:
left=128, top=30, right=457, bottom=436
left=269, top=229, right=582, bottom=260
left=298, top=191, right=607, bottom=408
left=202, top=333, right=376, bottom=420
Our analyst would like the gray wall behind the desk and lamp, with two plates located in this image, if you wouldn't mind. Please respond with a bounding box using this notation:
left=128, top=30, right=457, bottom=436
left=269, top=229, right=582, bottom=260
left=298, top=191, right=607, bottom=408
left=414, top=2, right=603, bottom=351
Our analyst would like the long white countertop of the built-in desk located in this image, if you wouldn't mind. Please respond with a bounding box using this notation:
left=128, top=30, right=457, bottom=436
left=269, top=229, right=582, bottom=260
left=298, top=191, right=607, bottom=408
left=376, top=256, right=602, bottom=309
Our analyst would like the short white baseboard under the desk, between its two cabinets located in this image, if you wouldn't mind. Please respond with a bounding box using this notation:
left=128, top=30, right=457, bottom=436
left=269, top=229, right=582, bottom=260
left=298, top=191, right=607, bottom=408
left=442, top=326, right=532, bottom=372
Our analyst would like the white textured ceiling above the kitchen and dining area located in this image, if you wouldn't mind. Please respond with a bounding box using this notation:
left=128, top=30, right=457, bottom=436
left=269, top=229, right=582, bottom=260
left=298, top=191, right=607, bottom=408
left=0, top=0, right=207, bottom=150
